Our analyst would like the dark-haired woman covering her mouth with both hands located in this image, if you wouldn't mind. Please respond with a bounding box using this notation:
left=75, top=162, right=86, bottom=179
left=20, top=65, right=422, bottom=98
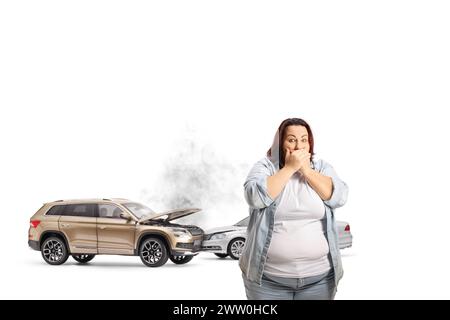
left=239, top=118, right=348, bottom=300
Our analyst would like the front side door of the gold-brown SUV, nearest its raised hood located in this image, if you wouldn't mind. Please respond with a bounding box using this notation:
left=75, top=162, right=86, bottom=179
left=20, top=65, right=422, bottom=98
left=97, top=203, right=136, bottom=255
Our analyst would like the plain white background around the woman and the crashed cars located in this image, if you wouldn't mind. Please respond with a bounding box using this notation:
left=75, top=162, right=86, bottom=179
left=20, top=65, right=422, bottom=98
left=0, top=0, right=450, bottom=299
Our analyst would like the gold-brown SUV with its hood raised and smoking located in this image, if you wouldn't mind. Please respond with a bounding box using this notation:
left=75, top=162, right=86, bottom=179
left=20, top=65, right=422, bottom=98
left=28, top=199, right=203, bottom=267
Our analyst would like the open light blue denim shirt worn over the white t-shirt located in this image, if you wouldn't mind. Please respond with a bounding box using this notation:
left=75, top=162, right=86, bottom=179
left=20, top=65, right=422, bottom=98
left=239, top=157, right=348, bottom=286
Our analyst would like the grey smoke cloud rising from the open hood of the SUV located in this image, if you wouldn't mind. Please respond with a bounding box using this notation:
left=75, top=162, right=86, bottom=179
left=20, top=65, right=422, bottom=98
left=142, top=129, right=250, bottom=228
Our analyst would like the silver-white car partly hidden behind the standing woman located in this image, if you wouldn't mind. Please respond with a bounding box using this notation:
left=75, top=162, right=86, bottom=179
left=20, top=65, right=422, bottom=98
left=202, top=217, right=353, bottom=260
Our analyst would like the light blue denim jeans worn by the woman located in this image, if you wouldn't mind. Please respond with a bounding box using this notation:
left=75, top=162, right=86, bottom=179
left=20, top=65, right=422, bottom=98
left=242, top=269, right=336, bottom=300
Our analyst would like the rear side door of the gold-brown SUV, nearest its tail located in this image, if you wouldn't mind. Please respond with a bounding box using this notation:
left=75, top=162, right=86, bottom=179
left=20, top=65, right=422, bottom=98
left=59, top=203, right=97, bottom=254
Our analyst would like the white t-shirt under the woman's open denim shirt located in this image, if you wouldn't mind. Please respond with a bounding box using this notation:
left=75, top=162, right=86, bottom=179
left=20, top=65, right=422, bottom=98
left=264, top=173, right=331, bottom=278
